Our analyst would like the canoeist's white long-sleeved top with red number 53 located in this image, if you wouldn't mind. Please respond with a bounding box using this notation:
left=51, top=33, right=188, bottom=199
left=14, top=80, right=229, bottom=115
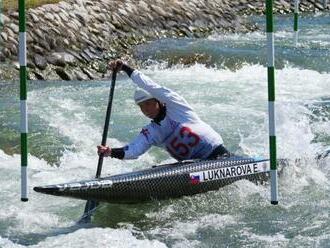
left=124, top=70, right=223, bottom=160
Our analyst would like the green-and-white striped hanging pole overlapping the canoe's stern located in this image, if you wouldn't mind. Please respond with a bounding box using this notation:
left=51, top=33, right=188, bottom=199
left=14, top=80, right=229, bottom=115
left=266, top=0, right=278, bottom=205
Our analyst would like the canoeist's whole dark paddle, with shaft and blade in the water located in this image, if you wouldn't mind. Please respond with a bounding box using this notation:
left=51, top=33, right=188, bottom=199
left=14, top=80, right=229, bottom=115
left=78, top=70, right=117, bottom=224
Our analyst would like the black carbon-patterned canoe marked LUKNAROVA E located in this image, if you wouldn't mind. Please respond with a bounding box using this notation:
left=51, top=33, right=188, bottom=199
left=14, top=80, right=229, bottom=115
left=34, top=157, right=269, bottom=203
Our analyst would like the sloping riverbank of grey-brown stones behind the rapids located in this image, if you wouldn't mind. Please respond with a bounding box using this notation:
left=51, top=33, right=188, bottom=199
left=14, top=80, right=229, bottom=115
left=0, top=0, right=324, bottom=80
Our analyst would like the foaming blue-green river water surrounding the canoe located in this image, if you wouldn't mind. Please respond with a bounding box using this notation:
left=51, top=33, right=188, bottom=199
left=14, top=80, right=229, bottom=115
left=0, top=14, right=330, bottom=247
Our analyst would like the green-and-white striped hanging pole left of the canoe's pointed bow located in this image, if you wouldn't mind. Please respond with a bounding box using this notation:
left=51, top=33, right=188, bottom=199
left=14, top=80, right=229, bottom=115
left=18, top=0, right=28, bottom=201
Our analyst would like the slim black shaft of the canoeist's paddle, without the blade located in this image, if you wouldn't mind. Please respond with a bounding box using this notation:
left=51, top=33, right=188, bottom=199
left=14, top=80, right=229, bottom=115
left=95, top=71, right=117, bottom=178
